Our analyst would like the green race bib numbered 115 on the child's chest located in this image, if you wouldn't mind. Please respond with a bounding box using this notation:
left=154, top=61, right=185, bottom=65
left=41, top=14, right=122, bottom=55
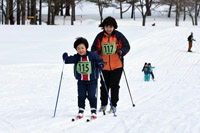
left=76, top=61, right=92, bottom=74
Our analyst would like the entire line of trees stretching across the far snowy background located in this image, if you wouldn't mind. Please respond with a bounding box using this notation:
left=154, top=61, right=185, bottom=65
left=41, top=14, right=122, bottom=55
left=1, top=0, right=200, bottom=26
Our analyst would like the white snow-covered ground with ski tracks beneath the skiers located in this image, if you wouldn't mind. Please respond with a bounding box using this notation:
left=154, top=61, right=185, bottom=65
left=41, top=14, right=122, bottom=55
left=0, top=1, right=200, bottom=133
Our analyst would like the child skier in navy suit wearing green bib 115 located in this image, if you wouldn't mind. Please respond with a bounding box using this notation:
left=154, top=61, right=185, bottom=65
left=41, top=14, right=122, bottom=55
left=63, top=37, right=104, bottom=119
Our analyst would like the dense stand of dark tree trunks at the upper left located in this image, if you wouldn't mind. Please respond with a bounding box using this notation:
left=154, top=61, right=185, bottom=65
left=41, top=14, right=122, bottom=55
left=1, top=0, right=77, bottom=25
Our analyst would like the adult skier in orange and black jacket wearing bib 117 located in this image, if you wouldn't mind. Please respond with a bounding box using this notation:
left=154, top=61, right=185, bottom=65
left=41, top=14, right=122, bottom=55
left=91, top=16, right=130, bottom=112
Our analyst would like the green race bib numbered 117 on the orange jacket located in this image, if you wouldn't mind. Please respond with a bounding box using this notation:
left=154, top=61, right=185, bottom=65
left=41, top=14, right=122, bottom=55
left=103, top=43, right=116, bottom=55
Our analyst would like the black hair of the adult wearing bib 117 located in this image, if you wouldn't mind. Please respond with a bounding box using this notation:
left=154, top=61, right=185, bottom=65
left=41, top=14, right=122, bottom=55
left=99, top=16, right=118, bottom=29
